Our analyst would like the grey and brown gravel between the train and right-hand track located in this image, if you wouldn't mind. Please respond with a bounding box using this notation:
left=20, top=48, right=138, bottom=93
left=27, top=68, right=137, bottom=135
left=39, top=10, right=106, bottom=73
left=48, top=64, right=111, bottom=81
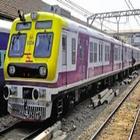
left=62, top=77, right=138, bottom=140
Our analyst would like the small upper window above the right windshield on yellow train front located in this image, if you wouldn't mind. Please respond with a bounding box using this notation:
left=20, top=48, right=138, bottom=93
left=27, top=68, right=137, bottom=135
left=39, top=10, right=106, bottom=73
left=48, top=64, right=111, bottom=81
left=35, top=20, right=52, bottom=29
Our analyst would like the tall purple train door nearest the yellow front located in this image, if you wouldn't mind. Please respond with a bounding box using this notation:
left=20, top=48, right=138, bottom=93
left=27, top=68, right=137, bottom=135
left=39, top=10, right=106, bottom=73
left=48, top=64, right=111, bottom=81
left=77, top=33, right=89, bottom=80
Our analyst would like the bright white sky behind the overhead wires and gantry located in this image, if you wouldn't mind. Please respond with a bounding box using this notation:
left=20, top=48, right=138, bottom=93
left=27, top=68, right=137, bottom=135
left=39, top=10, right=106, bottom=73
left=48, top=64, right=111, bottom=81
left=42, top=0, right=140, bottom=32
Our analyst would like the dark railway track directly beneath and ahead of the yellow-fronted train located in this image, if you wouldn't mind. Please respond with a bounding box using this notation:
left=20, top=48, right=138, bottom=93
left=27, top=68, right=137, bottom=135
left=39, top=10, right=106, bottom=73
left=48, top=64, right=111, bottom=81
left=0, top=121, right=47, bottom=140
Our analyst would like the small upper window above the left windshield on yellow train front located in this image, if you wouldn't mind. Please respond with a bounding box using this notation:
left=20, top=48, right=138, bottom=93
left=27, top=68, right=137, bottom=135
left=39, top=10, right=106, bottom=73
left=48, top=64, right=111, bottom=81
left=16, top=22, right=31, bottom=31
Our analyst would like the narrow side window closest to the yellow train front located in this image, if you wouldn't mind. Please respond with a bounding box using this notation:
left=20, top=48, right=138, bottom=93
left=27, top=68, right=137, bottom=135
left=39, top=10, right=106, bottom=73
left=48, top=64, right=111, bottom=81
left=62, top=35, right=67, bottom=65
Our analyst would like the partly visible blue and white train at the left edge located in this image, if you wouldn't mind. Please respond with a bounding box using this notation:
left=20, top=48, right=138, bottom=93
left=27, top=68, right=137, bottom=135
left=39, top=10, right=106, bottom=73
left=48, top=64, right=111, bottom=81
left=0, top=20, right=12, bottom=115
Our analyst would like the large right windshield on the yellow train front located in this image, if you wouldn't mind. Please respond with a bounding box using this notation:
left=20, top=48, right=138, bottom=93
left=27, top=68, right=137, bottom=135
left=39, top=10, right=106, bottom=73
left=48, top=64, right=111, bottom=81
left=34, top=33, right=53, bottom=57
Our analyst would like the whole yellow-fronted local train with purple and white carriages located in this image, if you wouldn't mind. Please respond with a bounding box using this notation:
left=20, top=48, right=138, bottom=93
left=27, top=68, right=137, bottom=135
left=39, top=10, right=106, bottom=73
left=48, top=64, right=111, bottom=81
left=4, top=12, right=140, bottom=121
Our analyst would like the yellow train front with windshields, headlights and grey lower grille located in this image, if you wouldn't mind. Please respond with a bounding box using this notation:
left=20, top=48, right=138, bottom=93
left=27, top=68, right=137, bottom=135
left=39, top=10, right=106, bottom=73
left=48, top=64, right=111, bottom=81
left=4, top=12, right=63, bottom=121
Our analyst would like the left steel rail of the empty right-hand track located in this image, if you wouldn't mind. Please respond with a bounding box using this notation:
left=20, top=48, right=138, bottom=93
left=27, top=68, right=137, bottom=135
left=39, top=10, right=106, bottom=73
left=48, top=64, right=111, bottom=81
left=91, top=76, right=140, bottom=140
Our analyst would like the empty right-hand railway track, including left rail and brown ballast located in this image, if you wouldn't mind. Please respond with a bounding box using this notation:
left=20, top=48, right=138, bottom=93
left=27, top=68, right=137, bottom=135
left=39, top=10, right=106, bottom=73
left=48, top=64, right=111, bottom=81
left=91, top=76, right=140, bottom=140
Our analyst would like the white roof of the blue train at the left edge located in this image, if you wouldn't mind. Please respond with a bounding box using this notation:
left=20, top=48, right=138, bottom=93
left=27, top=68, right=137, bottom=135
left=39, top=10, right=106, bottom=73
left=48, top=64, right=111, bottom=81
left=0, top=19, right=12, bottom=33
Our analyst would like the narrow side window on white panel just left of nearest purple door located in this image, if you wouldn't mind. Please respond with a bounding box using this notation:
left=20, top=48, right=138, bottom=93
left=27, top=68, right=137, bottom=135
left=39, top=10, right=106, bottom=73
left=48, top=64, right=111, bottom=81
left=72, top=38, right=76, bottom=64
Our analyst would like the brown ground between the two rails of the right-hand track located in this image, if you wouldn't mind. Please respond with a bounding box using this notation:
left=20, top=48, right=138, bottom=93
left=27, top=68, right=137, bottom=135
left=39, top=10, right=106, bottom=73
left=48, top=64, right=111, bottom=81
left=97, top=79, right=140, bottom=140
